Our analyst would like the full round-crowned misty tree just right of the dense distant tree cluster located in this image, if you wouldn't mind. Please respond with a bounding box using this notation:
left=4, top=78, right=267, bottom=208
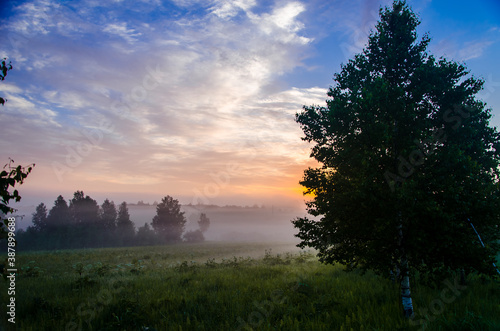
left=152, top=195, right=186, bottom=242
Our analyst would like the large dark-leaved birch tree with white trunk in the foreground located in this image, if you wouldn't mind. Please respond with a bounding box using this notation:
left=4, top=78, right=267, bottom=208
left=292, top=1, right=500, bottom=317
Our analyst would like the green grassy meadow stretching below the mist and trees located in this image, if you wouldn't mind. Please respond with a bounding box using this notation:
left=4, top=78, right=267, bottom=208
left=0, top=242, right=500, bottom=331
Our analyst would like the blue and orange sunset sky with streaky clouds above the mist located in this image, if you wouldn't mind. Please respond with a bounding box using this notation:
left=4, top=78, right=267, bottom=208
left=0, top=0, right=500, bottom=206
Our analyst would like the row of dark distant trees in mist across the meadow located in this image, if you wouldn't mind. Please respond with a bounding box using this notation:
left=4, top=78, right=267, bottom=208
left=12, top=191, right=210, bottom=250
